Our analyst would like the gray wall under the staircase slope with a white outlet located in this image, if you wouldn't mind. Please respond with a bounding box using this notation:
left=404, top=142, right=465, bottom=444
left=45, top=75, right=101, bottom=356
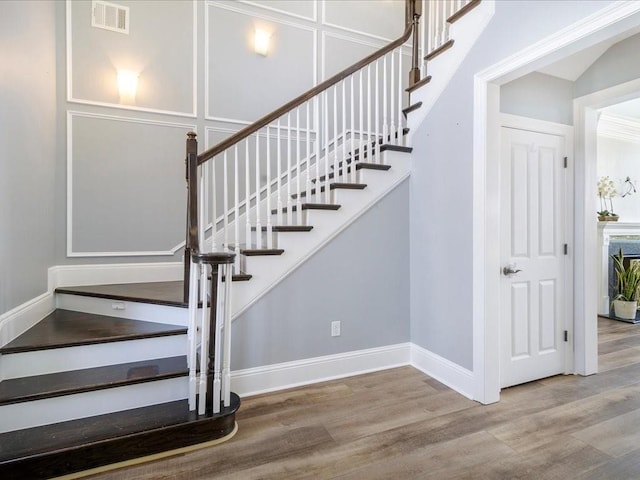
left=232, top=181, right=410, bottom=370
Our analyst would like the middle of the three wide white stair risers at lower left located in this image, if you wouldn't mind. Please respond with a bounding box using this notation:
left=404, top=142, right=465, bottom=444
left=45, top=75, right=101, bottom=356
left=0, top=334, right=187, bottom=379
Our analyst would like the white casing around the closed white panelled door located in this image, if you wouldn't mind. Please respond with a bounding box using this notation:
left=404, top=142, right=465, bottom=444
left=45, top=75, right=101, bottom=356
left=497, top=113, right=575, bottom=390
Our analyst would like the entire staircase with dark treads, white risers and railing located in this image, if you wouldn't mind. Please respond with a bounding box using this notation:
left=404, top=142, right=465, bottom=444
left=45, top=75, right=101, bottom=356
left=0, top=0, right=479, bottom=479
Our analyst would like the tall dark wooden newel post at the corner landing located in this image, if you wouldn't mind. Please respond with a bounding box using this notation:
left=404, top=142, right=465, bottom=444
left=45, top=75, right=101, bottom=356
left=183, top=132, right=200, bottom=302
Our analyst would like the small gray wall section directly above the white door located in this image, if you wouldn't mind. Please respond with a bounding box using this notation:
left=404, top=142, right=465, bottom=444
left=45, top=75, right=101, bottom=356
left=500, top=72, right=573, bottom=125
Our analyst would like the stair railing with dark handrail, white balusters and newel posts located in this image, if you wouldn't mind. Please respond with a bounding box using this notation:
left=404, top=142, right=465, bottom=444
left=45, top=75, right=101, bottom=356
left=184, top=0, right=460, bottom=414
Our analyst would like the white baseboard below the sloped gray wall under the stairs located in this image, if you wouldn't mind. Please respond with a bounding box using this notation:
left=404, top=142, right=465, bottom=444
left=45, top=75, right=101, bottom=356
left=231, top=343, right=411, bottom=397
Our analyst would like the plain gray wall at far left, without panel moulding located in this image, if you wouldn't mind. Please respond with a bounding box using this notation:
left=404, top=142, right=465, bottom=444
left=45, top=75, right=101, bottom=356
left=0, top=1, right=56, bottom=314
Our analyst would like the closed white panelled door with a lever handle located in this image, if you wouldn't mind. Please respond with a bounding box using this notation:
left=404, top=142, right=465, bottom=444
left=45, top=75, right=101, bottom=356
left=500, top=127, right=569, bottom=387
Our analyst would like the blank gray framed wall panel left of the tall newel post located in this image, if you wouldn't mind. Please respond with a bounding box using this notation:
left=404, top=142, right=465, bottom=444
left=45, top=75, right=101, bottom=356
left=67, top=112, right=195, bottom=256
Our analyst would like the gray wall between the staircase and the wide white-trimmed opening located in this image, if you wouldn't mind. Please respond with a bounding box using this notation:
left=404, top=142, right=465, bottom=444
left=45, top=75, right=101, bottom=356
left=410, top=1, right=611, bottom=369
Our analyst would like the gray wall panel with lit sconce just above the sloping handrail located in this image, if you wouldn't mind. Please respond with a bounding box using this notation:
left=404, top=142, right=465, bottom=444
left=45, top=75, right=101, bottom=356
left=205, top=4, right=316, bottom=121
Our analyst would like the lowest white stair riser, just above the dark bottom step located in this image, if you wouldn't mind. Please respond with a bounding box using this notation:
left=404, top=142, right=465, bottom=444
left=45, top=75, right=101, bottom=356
left=0, top=377, right=188, bottom=433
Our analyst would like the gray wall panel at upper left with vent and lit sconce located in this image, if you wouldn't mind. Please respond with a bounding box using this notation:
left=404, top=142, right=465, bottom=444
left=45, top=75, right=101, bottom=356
left=67, top=0, right=197, bottom=116
